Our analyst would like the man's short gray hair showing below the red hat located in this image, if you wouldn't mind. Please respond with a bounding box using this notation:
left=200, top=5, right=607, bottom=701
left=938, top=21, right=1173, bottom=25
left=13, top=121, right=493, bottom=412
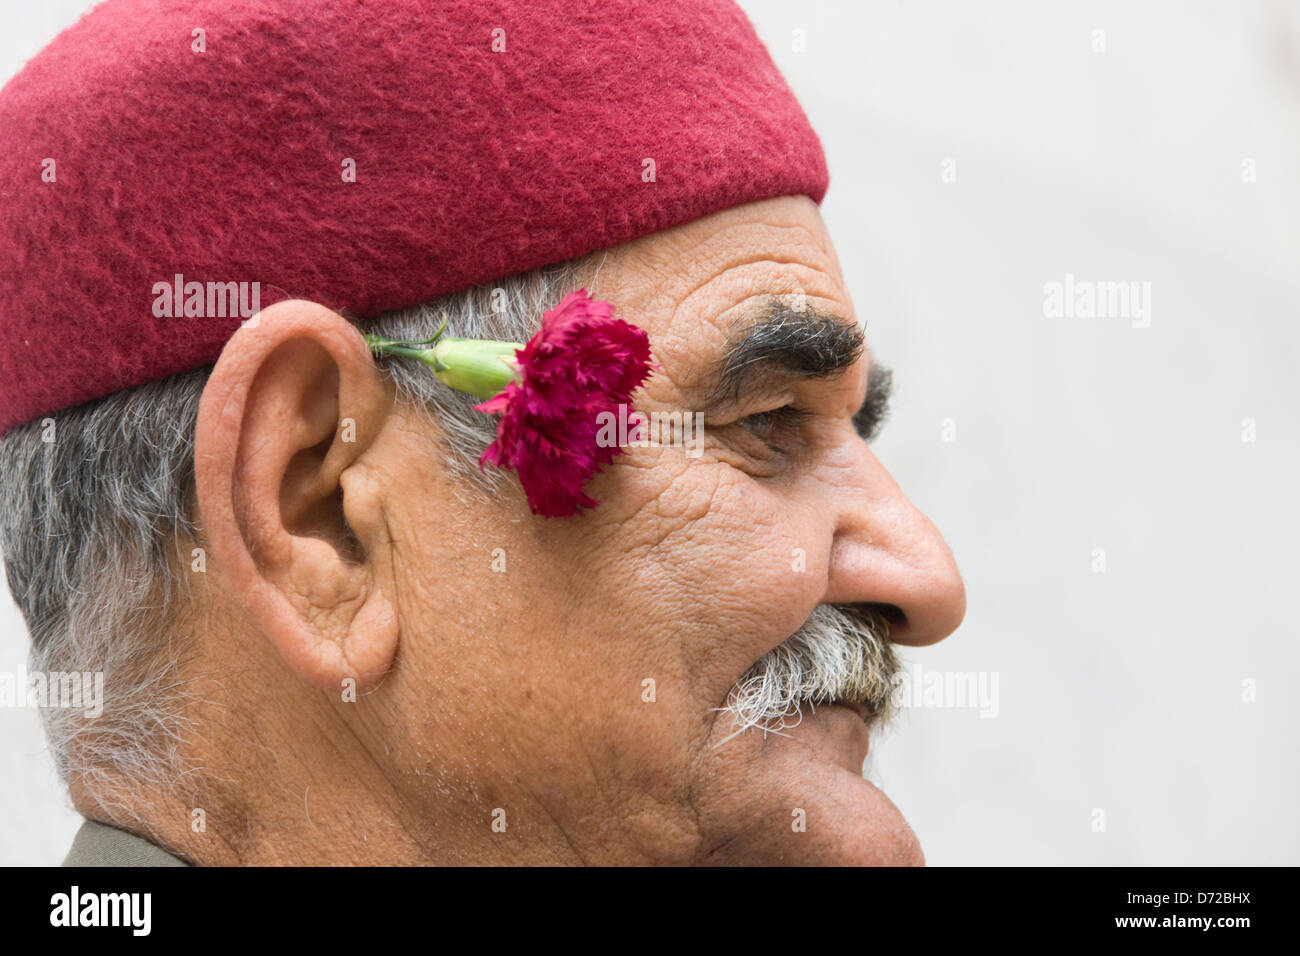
left=0, top=260, right=586, bottom=810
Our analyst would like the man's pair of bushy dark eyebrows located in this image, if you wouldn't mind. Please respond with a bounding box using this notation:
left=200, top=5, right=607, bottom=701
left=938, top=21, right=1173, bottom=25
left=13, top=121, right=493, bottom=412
left=710, top=299, right=893, bottom=441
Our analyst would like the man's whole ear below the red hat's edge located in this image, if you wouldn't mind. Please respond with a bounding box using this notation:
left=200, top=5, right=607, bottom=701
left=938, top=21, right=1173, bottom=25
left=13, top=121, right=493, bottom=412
left=195, top=300, right=398, bottom=691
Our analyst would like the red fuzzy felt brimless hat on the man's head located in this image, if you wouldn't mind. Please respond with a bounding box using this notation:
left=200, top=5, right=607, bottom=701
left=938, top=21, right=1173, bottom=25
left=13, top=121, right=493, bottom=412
left=0, top=0, right=827, bottom=431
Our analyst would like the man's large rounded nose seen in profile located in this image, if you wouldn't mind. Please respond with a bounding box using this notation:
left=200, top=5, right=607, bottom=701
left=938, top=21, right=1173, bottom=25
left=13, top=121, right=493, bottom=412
left=823, top=444, right=966, bottom=645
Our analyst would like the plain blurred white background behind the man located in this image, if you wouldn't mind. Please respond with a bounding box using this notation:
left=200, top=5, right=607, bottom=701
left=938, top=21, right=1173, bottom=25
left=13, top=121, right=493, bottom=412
left=0, top=0, right=1300, bottom=865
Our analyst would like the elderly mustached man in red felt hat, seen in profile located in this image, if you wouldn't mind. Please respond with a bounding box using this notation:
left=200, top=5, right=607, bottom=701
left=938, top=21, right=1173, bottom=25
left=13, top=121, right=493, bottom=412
left=0, top=0, right=965, bottom=865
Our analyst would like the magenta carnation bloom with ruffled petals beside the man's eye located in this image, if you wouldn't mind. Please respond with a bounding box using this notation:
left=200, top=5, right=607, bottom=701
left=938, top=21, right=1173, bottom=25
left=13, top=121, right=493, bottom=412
left=476, top=289, right=650, bottom=518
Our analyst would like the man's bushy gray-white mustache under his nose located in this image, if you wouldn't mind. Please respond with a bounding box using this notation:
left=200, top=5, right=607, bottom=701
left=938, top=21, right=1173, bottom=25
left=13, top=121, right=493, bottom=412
left=720, top=605, right=900, bottom=743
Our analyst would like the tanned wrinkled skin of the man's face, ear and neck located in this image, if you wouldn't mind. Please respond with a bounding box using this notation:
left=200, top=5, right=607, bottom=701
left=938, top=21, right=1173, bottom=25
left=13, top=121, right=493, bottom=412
left=74, top=198, right=965, bottom=864
